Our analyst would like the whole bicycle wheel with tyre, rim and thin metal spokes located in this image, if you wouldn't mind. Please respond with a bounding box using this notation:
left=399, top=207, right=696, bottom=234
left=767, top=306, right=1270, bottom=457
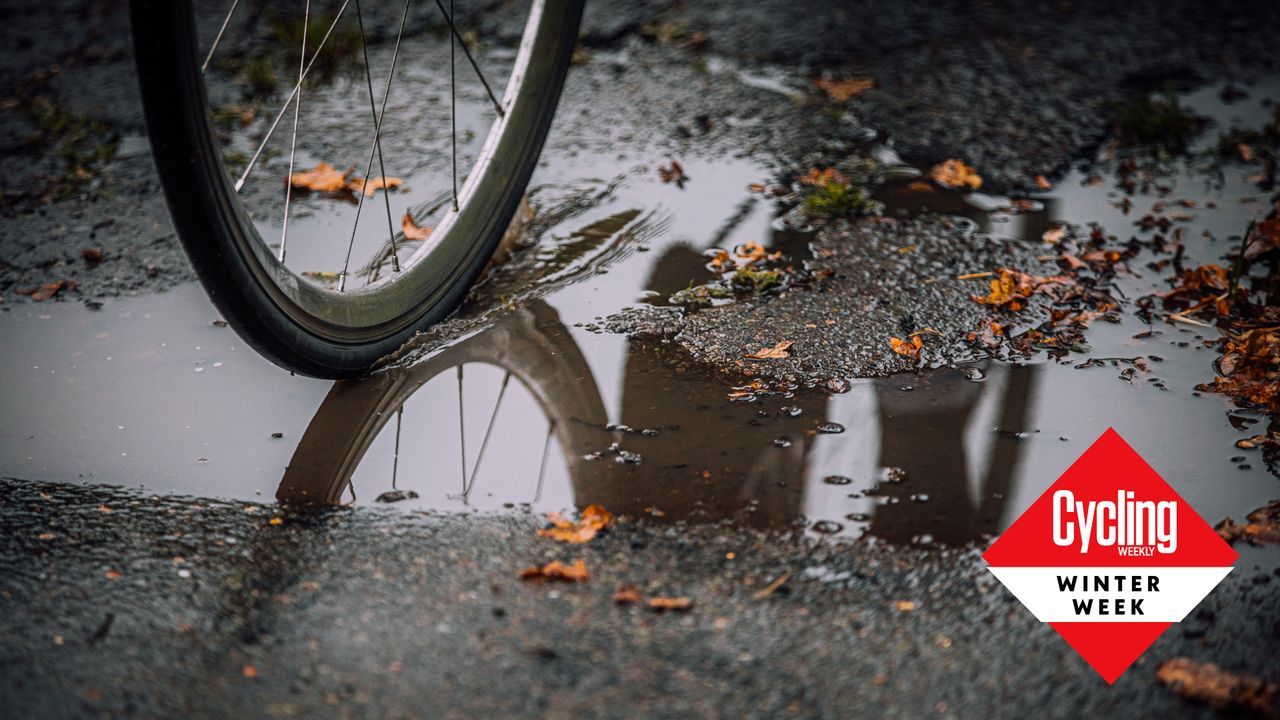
left=131, top=0, right=582, bottom=378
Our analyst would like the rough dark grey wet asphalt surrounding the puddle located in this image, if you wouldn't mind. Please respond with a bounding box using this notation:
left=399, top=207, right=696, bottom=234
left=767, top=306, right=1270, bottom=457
left=0, top=0, right=1280, bottom=717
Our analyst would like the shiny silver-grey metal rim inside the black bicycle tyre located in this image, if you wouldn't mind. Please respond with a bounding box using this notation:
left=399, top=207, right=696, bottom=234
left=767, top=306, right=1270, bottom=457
left=200, top=0, right=573, bottom=345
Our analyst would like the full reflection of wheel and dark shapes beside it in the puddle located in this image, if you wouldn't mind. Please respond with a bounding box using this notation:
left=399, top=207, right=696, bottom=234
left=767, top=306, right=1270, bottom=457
left=276, top=207, right=1037, bottom=543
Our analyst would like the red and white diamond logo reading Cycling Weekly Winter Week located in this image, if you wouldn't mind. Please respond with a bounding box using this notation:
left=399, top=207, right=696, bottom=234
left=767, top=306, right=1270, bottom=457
left=983, top=429, right=1236, bottom=684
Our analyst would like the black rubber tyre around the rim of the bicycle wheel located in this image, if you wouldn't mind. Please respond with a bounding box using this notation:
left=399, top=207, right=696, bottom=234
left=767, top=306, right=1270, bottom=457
left=131, top=0, right=582, bottom=378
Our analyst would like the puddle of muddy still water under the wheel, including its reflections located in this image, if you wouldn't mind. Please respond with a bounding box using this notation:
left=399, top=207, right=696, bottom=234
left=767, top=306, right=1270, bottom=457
left=0, top=75, right=1276, bottom=553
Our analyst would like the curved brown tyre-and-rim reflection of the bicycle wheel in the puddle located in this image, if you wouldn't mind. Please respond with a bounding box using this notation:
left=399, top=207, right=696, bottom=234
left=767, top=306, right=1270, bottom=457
left=276, top=301, right=605, bottom=505
